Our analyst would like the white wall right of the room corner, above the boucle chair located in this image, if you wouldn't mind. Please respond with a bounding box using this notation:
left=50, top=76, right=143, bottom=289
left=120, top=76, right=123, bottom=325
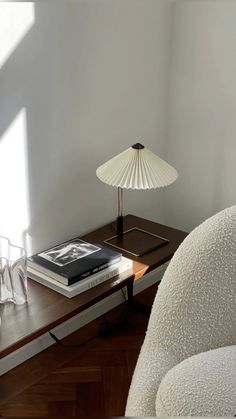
left=165, top=0, right=236, bottom=230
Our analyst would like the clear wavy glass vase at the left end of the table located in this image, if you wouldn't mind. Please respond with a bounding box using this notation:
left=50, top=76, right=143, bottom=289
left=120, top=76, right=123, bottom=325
left=0, top=240, right=27, bottom=304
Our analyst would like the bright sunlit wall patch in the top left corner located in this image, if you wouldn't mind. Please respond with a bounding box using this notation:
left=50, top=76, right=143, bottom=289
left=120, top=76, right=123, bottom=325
left=0, top=2, right=34, bottom=68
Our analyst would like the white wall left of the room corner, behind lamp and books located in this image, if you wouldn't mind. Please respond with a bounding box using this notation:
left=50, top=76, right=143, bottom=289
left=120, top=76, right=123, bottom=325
left=0, top=0, right=171, bottom=252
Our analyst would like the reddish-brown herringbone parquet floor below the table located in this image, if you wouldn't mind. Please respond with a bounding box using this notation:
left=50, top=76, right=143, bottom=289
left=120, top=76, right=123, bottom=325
left=0, top=286, right=159, bottom=418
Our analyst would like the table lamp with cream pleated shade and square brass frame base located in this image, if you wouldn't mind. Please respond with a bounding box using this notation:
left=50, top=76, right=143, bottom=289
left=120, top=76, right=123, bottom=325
left=96, top=143, right=178, bottom=256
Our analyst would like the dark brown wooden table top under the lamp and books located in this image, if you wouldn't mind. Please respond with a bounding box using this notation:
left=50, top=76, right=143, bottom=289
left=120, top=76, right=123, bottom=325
left=0, top=215, right=187, bottom=358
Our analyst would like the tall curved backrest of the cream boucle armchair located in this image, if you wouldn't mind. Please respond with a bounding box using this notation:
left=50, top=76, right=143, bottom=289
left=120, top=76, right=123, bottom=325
left=125, top=206, right=236, bottom=416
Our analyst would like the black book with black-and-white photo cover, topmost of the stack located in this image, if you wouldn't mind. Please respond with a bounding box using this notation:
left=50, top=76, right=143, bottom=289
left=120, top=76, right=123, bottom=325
left=28, top=238, right=121, bottom=285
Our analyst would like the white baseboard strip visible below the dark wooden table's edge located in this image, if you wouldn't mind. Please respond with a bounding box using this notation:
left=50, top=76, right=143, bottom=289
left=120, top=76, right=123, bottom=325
left=0, top=263, right=168, bottom=376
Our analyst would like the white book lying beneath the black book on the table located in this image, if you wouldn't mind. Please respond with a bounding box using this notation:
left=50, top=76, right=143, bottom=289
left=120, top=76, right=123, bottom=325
left=28, top=256, right=133, bottom=298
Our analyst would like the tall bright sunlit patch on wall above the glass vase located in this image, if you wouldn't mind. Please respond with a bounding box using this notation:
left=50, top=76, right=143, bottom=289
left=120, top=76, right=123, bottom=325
left=0, top=108, right=30, bottom=251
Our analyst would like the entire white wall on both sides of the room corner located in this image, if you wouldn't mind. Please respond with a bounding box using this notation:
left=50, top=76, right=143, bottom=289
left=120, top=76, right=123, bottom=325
left=5, top=0, right=236, bottom=244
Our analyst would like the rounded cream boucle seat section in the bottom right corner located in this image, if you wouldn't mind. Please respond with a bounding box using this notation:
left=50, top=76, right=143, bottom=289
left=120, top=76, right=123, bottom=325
left=156, top=346, right=236, bottom=417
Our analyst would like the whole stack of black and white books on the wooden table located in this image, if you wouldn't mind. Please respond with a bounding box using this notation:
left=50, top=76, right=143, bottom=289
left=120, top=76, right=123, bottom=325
left=27, top=238, right=132, bottom=298
